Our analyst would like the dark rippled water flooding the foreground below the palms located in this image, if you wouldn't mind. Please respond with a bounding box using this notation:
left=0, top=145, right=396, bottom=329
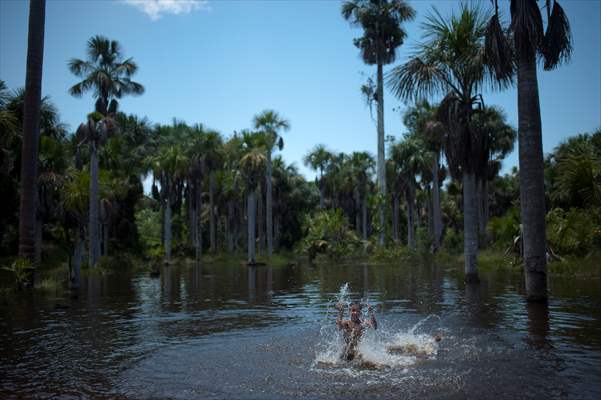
left=0, top=265, right=601, bottom=399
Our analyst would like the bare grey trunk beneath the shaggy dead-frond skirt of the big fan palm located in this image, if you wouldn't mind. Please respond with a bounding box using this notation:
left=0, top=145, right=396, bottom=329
left=463, top=171, right=478, bottom=282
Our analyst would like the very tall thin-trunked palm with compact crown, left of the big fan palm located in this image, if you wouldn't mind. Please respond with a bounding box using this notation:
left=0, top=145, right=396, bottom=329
left=342, top=0, right=415, bottom=245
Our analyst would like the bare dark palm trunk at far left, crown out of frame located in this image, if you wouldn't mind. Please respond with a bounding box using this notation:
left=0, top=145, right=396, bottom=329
left=19, top=0, right=46, bottom=284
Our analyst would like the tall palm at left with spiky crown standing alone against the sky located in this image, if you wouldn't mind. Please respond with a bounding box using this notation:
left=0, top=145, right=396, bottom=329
left=69, top=35, right=144, bottom=267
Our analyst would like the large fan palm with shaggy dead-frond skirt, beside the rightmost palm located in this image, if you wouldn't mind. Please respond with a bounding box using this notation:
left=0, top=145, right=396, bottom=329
left=388, top=3, right=504, bottom=281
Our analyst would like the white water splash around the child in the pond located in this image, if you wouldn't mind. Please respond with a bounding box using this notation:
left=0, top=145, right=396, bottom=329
left=313, top=283, right=440, bottom=376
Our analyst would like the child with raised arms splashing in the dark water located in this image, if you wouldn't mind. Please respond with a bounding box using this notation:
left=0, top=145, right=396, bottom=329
left=336, top=303, right=378, bottom=361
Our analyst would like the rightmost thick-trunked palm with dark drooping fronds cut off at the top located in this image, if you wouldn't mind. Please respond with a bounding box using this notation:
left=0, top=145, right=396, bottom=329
left=486, top=0, right=572, bottom=301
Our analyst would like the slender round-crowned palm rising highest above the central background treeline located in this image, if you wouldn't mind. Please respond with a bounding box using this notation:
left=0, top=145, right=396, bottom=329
left=253, top=110, right=290, bottom=257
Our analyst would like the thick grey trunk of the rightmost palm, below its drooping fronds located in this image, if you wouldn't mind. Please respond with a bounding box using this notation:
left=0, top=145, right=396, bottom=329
left=518, top=55, right=547, bottom=301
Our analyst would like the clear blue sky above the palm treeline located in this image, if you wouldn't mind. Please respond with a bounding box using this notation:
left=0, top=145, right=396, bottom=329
left=0, top=0, right=601, bottom=178
